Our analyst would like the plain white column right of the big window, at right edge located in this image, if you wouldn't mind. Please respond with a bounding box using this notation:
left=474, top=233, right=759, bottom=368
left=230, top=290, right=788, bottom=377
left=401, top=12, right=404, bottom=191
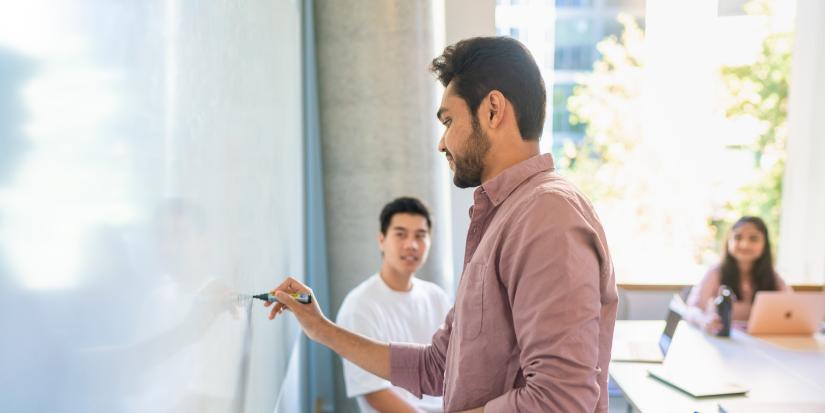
left=777, top=0, right=825, bottom=284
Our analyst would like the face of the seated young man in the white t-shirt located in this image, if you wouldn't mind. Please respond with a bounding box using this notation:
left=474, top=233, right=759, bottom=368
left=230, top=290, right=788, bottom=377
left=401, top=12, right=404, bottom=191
left=378, top=213, right=430, bottom=274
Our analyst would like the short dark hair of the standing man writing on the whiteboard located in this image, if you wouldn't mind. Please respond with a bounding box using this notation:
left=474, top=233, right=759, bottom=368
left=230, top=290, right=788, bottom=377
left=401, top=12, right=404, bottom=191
left=430, top=37, right=547, bottom=139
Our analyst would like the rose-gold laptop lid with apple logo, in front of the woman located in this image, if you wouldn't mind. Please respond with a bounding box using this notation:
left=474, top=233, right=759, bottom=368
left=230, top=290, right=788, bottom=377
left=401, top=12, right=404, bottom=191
left=748, top=291, right=825, bottom=335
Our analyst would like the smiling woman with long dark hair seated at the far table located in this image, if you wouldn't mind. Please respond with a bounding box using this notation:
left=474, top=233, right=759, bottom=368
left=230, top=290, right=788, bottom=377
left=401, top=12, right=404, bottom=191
left=686, top=216, right=791, bottom=333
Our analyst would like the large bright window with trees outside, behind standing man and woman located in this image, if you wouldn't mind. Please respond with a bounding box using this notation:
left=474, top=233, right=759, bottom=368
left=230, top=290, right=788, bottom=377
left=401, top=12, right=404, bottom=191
left=497, top=0, right=794, bottom=284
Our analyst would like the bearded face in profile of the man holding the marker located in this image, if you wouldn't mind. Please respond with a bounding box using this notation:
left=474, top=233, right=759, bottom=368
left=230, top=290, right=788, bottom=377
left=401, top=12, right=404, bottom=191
left=436, top=82, right=490, bottom=188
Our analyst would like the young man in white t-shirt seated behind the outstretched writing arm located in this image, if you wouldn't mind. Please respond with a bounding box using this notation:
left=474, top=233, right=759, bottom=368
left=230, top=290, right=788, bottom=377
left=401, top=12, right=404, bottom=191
left=337, top=197, right=451, bottom=413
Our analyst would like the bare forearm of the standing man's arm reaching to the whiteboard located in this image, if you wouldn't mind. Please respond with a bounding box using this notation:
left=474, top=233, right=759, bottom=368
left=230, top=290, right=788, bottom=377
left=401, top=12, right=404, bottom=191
left=316, top=322, right=390, bottom=380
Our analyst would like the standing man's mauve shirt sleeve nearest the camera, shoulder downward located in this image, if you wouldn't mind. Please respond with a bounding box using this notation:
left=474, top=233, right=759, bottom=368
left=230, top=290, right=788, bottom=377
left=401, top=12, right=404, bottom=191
left=485, top=193, right=606, bottom=412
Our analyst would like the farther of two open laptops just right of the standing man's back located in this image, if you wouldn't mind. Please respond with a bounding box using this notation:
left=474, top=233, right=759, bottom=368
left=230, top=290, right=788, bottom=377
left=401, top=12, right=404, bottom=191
left=610, top=294, right=685, bottom=363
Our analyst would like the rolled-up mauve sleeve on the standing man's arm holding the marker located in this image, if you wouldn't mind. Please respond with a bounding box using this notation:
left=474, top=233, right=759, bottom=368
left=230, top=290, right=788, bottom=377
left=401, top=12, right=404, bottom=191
left=390, top=310, right=454, bottom=398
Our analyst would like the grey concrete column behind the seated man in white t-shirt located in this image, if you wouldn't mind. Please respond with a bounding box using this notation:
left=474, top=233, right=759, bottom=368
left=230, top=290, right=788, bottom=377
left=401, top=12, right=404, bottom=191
left=315, top=0, right=452, bottom=412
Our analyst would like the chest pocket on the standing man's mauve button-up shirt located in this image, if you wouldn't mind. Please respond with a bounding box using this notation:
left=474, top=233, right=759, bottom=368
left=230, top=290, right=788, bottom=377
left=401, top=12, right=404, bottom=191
left=456, top=262, right=487, bottom=340
